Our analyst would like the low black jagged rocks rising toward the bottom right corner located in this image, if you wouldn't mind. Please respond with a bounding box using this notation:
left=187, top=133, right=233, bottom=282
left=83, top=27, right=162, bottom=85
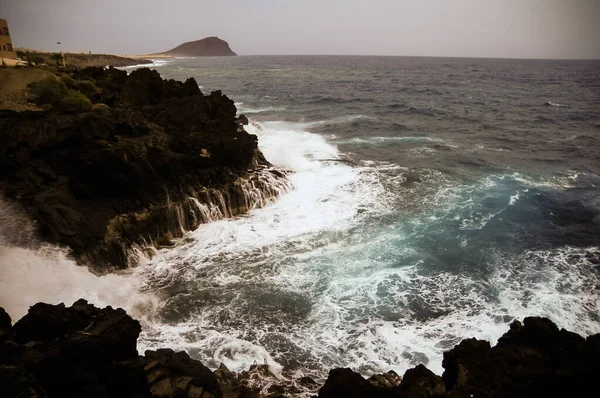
left=319, top=318, right=600, bottom=398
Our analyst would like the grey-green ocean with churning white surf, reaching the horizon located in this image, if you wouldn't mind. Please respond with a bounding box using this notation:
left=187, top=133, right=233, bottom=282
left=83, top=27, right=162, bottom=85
left=0, top=56, right=600, bottom=386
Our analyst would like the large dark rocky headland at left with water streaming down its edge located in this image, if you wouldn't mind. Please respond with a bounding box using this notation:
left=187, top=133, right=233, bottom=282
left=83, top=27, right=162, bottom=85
left=0, top=68, right=287, bottom=268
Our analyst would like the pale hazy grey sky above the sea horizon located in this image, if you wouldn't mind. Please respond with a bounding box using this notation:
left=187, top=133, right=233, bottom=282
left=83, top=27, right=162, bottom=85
left=0, top=0, right=600, bottom=58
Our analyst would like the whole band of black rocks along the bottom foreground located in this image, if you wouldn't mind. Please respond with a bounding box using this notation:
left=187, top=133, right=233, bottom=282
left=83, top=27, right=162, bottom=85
left=0, top=299, right=600, bottom=398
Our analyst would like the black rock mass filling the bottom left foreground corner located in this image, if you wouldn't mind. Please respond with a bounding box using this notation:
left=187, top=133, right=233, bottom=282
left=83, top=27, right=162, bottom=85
left=0, top=300, right=222, bottom=398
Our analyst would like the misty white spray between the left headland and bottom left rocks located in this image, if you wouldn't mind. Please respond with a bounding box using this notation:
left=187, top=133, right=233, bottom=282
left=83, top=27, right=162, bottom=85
left=0, top=200, right=157, bottom=322
